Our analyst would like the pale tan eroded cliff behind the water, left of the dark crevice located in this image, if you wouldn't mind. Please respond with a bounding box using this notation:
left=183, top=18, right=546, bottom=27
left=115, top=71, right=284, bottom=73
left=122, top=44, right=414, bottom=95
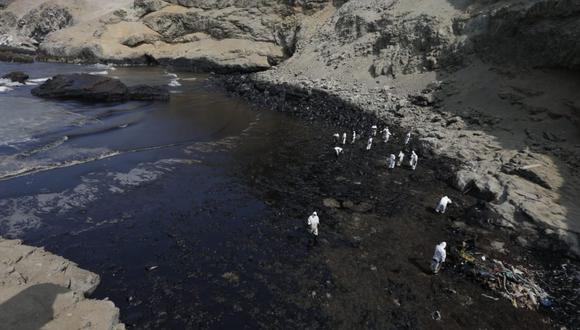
left=0, top=0, right=334, bottom=72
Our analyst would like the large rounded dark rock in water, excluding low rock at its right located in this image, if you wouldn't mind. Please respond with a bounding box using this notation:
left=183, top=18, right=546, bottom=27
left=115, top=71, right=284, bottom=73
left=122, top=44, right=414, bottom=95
left=32, top=73, right=129, bottom=102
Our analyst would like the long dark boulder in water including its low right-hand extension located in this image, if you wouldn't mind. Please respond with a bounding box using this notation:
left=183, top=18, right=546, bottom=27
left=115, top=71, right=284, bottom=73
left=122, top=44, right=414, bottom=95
left=32, top=73, right=169, bottom=102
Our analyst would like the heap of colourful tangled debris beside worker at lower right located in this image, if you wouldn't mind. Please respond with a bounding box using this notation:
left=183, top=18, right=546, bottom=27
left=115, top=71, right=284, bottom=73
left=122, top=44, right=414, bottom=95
left=459, top=248, right=553, bottom=309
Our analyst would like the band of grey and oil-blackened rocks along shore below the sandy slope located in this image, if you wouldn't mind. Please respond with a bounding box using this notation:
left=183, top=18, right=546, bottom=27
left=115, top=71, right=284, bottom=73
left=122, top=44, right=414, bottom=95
left=216, top=70, right=580, bottom=258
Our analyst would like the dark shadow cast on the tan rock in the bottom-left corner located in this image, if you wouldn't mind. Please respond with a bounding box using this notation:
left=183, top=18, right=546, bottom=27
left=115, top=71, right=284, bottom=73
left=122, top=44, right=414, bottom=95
left=0, top=283, right=69, bottom=330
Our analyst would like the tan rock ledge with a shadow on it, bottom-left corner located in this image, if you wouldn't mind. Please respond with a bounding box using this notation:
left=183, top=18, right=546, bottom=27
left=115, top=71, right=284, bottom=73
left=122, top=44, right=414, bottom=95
left=0, top=238, right=125, bottom=330
